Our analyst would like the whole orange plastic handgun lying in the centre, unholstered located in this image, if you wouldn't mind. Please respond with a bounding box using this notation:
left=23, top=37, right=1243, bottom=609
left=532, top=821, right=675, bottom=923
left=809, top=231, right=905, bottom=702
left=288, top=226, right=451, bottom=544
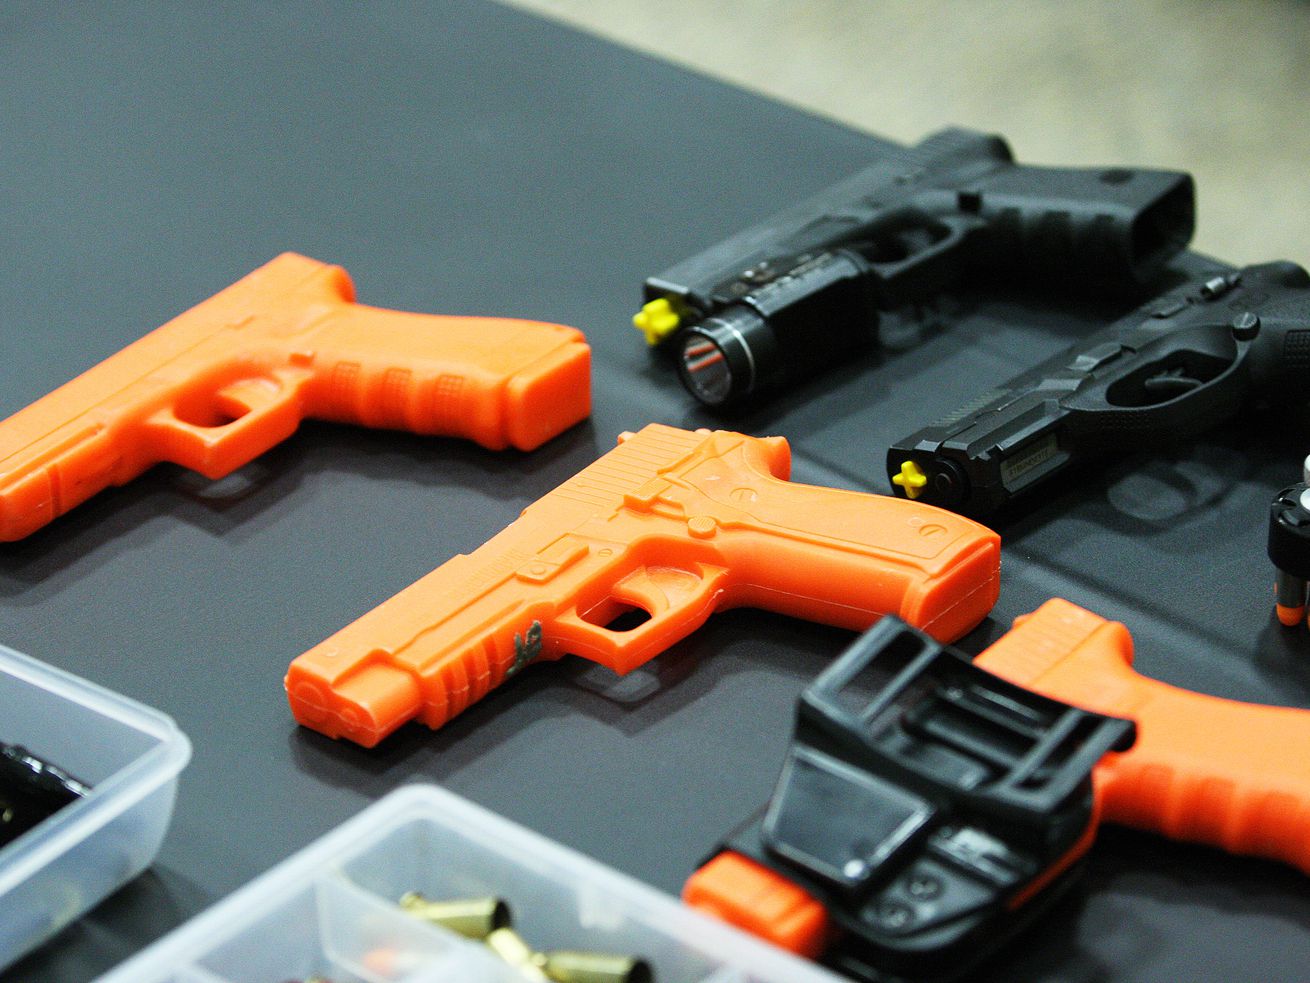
left=286, top=425, right=1000, bottom=747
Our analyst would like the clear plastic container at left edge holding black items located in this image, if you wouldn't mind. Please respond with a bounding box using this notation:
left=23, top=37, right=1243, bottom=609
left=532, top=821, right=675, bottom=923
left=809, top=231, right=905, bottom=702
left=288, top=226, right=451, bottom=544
left=0, top=645, right=191, bottom=969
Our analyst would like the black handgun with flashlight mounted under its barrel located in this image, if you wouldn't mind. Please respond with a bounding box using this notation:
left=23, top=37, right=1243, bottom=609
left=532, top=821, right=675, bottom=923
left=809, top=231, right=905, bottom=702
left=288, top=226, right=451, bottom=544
left=633, top=130, right=1195, bottom=406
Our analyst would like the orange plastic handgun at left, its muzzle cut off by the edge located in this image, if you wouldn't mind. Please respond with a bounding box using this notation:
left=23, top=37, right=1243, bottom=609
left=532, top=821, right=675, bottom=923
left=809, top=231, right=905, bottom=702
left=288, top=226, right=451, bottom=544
left=0, top=253, right=591, bottom=541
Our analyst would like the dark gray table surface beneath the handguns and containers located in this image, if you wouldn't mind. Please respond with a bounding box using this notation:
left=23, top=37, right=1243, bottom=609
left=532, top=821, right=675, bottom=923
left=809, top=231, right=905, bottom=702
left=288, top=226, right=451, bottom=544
left=0, top=1, right=1310, bottom=980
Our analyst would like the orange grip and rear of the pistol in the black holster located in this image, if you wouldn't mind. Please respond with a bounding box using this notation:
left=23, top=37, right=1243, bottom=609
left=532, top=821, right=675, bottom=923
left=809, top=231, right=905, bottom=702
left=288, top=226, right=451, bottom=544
left=977, top=599, right=1310, bottom=873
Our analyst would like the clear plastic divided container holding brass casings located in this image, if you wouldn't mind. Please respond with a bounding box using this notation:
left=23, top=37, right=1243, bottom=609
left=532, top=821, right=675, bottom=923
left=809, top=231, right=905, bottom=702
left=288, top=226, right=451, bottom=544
left=101, top=785, right=840, bottom=983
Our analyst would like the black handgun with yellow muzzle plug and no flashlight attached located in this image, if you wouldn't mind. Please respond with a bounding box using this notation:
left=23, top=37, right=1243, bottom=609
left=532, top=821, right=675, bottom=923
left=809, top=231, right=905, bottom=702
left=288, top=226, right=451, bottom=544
left=887, top=262, right=1310, bottom=518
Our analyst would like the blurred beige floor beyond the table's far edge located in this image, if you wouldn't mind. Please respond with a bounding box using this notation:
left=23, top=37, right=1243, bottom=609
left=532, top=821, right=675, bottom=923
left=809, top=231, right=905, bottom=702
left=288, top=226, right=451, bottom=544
left=507, top=0, right=1310, bottom=265
